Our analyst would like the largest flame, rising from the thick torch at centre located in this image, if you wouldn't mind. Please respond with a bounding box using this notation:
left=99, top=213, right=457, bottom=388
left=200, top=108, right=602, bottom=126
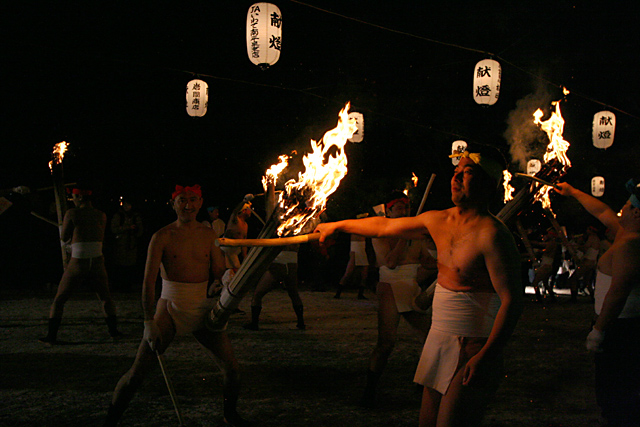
left=278, top=103, right=358, bottom=236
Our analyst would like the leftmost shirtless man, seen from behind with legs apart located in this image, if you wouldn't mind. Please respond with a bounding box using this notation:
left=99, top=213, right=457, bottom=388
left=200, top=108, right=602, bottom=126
left=40, top=188, right=122, bottom=344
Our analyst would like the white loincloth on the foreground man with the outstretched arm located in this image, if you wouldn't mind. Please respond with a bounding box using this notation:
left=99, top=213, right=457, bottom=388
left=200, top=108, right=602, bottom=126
left=413, top=284, right=500, bottom=394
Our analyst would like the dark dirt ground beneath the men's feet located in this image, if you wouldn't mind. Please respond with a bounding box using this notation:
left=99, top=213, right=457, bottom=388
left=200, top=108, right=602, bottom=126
left=0, top=288, right=599, bottom=427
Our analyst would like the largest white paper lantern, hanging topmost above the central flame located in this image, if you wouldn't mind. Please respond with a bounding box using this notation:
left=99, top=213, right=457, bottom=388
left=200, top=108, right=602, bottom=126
left=247, top=3, right=282, bottom=69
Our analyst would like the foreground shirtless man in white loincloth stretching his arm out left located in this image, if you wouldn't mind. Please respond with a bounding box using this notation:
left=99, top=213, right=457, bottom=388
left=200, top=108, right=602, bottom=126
left=317, top=152, right=523, bottom=427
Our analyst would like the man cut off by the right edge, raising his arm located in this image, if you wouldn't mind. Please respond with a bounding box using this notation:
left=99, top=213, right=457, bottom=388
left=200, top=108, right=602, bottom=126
left=556, top=180, right=640, bottom=426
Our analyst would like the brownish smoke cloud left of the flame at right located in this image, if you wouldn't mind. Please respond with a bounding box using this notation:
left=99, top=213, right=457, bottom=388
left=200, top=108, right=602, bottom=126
left=504, top=85, right=553, bottom=171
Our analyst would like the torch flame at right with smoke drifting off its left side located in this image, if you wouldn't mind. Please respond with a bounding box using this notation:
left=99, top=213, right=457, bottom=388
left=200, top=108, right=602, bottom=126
left=533, top=101, right=571, bottom=210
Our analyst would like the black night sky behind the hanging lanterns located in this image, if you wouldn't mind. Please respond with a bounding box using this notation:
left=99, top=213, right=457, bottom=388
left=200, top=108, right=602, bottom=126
left=0, top=0, right=640, bottom=227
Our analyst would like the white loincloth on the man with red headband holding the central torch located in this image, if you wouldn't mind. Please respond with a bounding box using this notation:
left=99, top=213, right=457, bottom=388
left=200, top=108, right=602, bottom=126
left=160, top=279, right=220, bottom=335
